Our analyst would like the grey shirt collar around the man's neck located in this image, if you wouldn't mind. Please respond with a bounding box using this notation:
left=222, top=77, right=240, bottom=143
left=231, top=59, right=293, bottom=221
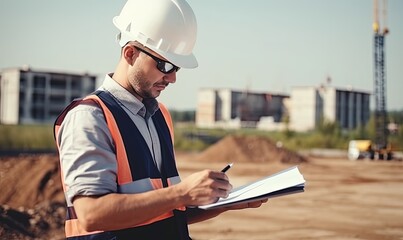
left=100, top=73, right=159, bottom=118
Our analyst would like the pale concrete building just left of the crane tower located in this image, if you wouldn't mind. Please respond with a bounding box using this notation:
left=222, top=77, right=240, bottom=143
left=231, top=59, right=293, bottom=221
left=290, top=86, right=370, bottom=131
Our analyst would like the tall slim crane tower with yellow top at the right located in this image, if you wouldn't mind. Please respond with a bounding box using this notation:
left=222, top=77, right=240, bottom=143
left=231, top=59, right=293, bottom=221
left=371, top=0, right=392, bottom=160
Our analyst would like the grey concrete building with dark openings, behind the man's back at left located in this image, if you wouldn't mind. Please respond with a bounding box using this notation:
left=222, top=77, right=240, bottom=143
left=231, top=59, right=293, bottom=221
left=0, top=67, right=96, bottom=124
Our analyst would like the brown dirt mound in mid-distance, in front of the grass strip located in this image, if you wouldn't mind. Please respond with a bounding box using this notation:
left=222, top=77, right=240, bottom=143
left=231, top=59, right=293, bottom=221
left=197, top=136, right=307, bottom=164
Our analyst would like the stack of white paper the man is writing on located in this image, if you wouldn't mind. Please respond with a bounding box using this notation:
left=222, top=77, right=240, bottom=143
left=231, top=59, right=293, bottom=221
left=199, top=166, right=305, bottom=209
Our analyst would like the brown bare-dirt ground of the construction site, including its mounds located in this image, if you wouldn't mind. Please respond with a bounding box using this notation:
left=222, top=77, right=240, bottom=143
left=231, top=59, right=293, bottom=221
left=0, top=138, right=403, bottom=240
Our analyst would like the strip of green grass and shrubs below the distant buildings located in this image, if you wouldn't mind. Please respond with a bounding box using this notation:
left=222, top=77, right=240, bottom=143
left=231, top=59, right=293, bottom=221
left=0, top=124, right=403, bottom=151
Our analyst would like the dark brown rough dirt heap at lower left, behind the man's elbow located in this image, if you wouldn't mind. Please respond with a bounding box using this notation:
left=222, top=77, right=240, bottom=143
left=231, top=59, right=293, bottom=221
left=0, top=154, right=66, bottom=240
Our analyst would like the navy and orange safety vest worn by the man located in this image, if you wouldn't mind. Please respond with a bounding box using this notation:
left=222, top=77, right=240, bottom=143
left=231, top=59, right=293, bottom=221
left=54, top=91, right=189, bottom=239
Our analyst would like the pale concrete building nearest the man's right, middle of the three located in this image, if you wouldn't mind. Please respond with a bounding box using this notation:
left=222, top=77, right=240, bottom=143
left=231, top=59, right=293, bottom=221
left=196, top=89, right=289, bottom=128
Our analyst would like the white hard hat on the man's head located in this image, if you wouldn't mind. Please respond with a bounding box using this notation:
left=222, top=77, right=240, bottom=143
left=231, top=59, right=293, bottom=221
left=113, top=0, right=198, bottom=68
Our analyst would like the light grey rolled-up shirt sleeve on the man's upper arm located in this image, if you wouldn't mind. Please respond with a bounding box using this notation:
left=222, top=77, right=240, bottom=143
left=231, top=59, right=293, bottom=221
left=57, top=103, right=117, bottom=205
